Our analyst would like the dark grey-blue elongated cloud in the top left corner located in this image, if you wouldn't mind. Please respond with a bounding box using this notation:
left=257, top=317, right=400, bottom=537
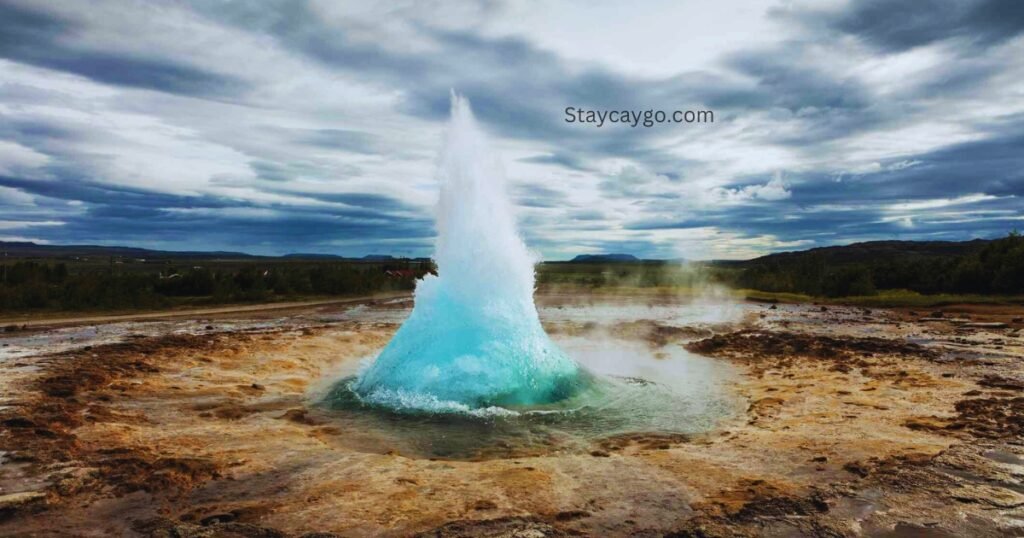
left=0, top=2, right=246, bottom=96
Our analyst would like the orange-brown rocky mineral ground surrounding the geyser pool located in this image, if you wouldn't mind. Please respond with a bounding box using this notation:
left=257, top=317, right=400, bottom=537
left=0, top=296, right=1024, bottom=537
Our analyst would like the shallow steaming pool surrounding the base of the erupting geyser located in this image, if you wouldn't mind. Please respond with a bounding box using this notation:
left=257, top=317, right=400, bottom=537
left=310, top=302, right=745, bottom=459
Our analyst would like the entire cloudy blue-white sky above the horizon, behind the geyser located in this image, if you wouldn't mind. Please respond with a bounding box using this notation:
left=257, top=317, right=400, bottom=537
left=0, top=0, right=1024, bottom=259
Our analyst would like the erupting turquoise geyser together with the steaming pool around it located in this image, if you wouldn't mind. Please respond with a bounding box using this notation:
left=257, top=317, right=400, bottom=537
left=318, top=93, right=735, bottom=457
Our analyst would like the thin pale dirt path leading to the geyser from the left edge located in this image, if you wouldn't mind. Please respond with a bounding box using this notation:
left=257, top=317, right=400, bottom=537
left=0, top=291, right=411, bottom=328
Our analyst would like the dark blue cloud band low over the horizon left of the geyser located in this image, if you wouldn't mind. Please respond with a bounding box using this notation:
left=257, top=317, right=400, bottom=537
left=0, top=169, right=434, bottom=253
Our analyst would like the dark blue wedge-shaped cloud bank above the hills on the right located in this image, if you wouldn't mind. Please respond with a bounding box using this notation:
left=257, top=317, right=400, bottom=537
left=624, top=126, right=1024, bottom=244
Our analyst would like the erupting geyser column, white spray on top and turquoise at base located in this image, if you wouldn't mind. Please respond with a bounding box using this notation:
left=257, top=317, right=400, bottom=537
left=351, top=93, right=584, bottom=411
